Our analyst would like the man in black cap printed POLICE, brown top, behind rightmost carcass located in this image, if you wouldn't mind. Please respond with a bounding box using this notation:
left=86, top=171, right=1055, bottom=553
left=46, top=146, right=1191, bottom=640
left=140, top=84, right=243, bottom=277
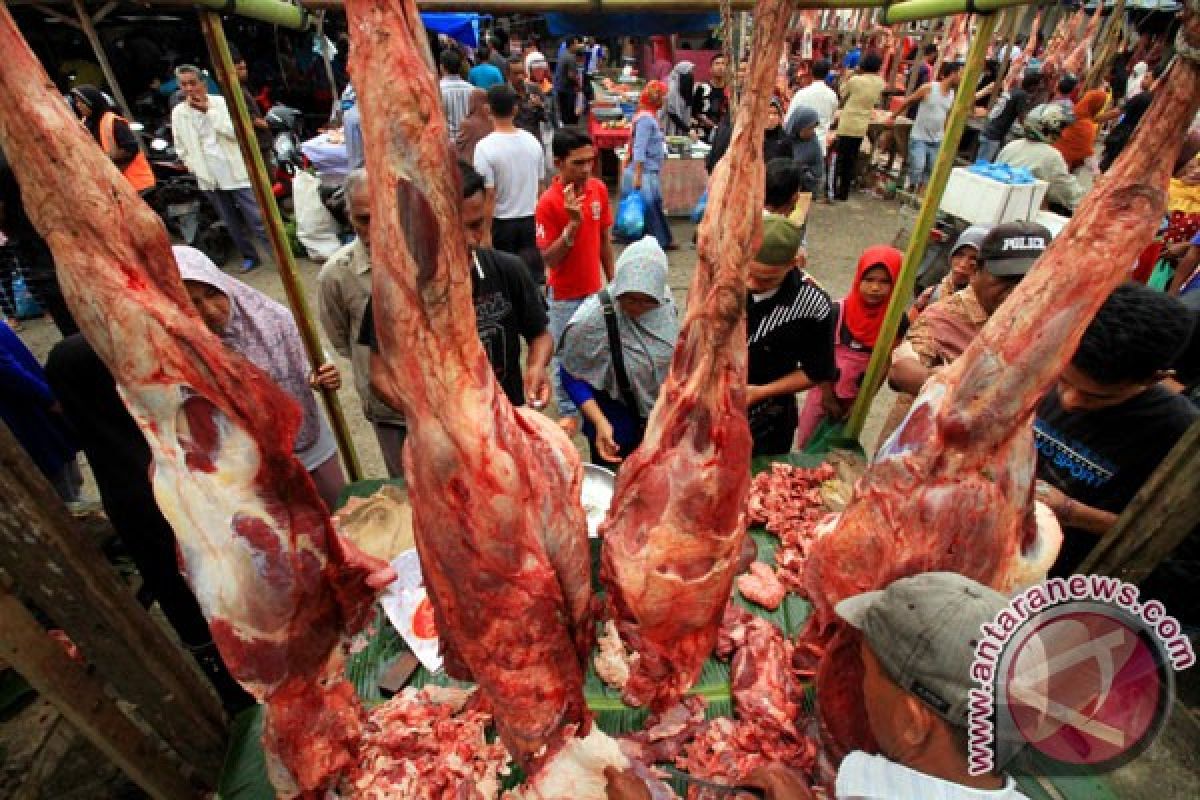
left=883, top=222, right=1051, bottom=434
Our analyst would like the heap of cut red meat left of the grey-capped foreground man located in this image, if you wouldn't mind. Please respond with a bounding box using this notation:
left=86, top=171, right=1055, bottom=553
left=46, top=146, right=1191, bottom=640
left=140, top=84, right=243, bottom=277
left=676, top=603, right=816, bottom=786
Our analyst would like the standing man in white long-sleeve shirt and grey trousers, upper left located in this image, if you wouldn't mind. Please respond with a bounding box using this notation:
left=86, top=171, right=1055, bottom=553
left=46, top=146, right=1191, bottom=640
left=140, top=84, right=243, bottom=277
left=170, top=65, right=269, bottom=272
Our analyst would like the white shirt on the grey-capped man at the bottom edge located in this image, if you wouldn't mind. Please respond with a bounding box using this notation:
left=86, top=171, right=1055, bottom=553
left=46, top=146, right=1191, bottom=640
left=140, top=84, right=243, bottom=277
left=835, top=750, right=1028, bottom=800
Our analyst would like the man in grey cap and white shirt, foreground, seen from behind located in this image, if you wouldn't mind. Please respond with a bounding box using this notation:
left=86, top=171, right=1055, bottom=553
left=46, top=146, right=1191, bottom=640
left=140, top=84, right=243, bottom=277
left=729, top=572, right=1025, bottom=800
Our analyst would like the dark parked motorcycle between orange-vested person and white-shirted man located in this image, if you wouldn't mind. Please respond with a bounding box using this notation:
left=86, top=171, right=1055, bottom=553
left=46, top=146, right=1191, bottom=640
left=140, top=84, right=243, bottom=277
left=146, top=126, right=233, bottom=266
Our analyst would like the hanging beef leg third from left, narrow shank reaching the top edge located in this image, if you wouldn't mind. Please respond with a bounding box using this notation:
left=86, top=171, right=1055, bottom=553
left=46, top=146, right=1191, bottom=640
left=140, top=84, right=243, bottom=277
left=600, top=0, right=791, bottom=710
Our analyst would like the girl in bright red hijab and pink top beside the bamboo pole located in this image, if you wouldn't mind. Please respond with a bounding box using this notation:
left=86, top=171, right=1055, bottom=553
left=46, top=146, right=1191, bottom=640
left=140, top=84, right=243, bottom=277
left=796, top=245, right=907, bottom=450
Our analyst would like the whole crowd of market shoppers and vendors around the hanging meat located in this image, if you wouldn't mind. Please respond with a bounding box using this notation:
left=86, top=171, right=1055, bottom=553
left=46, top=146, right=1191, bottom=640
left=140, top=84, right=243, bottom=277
left=0, top=17, right=1200, bottom=798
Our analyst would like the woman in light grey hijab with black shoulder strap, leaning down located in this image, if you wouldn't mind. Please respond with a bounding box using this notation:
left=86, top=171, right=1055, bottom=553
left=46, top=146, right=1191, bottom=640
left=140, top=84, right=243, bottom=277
left=558, top=236, right=679, bottom=468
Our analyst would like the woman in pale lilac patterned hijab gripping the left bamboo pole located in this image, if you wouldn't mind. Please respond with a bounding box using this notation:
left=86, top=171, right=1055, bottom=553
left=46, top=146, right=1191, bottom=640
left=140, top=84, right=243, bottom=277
left=172, top=246, right=346, bottom=510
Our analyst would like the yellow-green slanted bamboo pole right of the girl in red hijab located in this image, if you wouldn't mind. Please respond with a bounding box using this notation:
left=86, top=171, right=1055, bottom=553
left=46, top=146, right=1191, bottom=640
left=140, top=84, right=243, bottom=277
left=846, top=6, right=996, bottom=439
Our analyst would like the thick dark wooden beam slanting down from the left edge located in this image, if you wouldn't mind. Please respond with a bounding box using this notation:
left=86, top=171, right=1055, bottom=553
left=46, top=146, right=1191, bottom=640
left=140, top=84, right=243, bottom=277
left=0, top=425, right=226, bottom=786
